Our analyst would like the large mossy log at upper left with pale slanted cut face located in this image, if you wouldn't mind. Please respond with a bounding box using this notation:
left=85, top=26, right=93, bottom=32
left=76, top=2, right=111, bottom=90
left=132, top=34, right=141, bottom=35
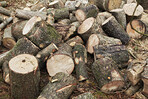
left=23, top=16, right=62, bottom=49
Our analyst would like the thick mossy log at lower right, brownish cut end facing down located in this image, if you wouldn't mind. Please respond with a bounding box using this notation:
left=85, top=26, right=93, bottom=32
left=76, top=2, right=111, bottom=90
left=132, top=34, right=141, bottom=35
left=92, top=57, right=124, bottom=93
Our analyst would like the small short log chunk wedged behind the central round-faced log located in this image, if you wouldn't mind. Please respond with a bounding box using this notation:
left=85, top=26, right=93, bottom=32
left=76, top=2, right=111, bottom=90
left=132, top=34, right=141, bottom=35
left=66, top=36, right=84, bottom=47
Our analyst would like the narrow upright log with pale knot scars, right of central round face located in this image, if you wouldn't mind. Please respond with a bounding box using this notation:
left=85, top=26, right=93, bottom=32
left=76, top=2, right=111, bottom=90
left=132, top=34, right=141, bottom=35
left=73, top=44, right=88, bottom=81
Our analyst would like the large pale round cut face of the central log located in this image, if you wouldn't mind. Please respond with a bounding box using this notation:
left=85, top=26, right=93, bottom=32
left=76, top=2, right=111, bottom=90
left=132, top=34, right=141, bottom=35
left=47, top=54, right=74, bottom=76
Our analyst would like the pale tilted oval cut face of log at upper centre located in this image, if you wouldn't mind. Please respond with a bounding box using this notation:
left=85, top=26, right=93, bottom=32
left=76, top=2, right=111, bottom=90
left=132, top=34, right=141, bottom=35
left=78, top=17, right=95, bottom=34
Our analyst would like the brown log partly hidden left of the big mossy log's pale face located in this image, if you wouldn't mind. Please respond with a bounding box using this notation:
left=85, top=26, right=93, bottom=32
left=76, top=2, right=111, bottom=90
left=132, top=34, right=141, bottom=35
left=11, top=21, right=27, bottom=40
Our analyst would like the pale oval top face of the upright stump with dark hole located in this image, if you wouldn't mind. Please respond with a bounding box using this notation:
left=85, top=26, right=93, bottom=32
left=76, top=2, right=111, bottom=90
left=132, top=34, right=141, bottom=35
left=9, top=54, right=38, bottom=74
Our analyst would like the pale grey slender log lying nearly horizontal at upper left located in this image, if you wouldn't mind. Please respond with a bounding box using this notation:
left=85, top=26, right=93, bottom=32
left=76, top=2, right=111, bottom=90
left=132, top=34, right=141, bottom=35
left=15, top=9, right=47, bottom=20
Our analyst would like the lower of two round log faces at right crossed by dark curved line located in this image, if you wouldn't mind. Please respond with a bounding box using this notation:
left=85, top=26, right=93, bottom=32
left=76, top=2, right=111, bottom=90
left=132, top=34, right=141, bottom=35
left=126, top=20, right=146, bottom=39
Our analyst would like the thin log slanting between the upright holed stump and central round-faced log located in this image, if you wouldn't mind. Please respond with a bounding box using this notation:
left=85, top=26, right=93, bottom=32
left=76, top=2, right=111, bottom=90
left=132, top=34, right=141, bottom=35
left=36, top=43, right=58, bottom=68
